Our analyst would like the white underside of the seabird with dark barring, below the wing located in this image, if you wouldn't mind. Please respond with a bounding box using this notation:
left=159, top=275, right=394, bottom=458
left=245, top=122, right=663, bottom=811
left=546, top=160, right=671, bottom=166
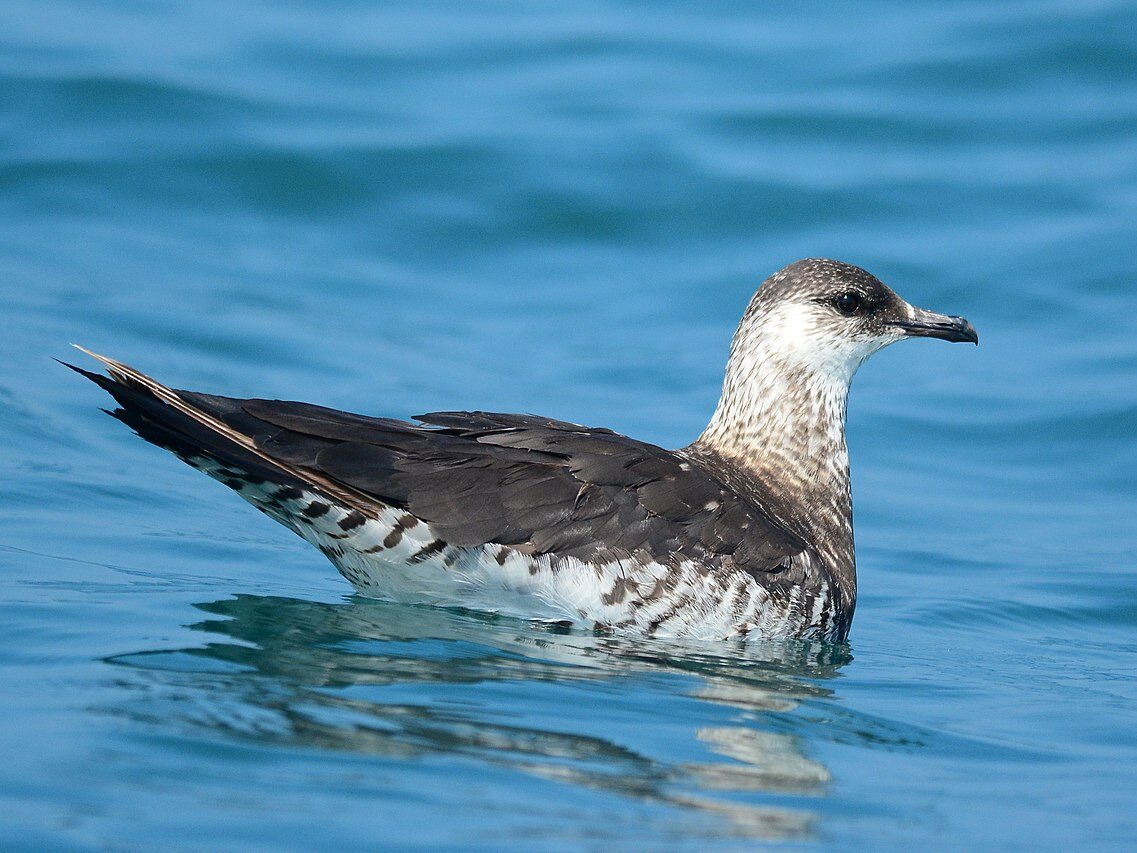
left=188, top=457, right=828, bottom=639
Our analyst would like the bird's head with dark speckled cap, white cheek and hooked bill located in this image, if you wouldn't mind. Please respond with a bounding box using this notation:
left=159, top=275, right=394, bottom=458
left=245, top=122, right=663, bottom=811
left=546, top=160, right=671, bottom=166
left=732, top=258, right=979, bottom=383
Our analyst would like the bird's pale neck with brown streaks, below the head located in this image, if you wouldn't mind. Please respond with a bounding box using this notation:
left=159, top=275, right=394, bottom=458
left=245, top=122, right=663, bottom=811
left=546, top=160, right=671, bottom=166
left=695, top=341, right=858, bottom=595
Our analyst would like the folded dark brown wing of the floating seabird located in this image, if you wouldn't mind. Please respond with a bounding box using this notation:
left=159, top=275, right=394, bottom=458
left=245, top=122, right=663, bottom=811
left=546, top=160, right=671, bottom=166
left=177, top=400, right=805, bottom=572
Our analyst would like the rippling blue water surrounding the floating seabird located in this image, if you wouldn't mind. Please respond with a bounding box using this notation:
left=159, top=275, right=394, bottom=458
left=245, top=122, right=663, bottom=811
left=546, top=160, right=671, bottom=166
left=0, top=0, right=1137, bottom=850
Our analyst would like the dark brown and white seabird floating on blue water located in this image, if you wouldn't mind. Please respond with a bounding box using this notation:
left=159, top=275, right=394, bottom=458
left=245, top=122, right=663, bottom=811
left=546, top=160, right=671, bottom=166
left=66, top=258, right=979, bottom=643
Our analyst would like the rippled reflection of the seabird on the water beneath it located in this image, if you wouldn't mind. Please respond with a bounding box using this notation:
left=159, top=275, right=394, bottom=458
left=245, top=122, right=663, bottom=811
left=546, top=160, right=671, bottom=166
left=108, top=595, right=850, bottom=838
